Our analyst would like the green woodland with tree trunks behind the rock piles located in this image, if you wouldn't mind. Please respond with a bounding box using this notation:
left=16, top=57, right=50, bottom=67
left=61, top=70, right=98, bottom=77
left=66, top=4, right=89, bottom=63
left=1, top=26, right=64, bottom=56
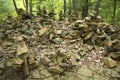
left=0, top=0, right=120, bottom=26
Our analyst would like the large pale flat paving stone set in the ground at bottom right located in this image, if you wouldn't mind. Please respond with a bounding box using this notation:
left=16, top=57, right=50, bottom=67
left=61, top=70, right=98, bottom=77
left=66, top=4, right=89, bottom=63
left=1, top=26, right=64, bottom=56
left=78, top=67, right=93, bottom=77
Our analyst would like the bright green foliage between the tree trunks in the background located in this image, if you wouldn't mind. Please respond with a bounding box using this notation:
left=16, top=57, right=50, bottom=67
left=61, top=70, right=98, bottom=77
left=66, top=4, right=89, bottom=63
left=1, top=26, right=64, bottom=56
left=0, top=0, right=120, bottom=26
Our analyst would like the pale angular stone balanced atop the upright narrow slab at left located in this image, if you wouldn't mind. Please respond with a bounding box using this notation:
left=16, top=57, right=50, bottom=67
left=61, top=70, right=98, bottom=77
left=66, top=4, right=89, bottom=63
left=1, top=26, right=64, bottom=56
left=17, top=43, right=28, bottom=55
